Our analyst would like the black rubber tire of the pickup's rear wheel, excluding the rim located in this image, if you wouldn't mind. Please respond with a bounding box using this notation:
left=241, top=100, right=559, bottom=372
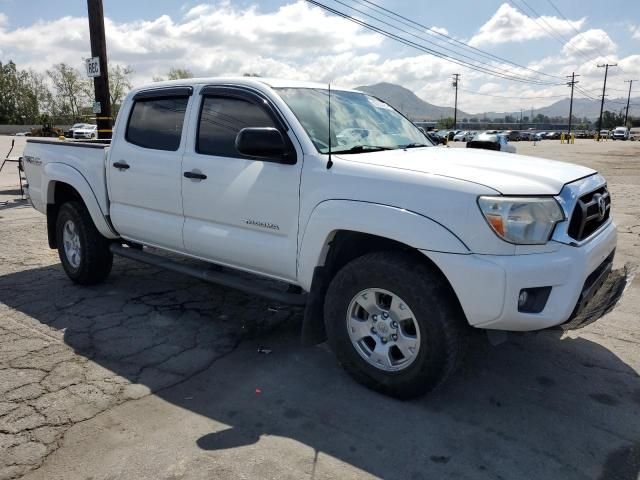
left=56, top=202, right=113, bottom=285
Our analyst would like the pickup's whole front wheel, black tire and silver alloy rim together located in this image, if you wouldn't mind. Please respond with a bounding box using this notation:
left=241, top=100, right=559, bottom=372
left=324, top=252, right=466, bottom=399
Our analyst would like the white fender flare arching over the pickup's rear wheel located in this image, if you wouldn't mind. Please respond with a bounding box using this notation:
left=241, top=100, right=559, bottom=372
left=43, top=163, right=119, bottom=239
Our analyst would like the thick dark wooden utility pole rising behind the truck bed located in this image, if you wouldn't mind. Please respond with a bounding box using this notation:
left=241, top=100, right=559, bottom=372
left=87, top=0, right=113, bottom=138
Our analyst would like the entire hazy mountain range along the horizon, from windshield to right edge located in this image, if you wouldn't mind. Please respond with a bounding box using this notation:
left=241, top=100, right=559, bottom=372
left=356, top=83, right=640, bottom=120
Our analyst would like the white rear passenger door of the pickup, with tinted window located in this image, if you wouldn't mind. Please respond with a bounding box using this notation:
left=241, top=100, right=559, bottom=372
left=107, top=87, right=193, bottom=251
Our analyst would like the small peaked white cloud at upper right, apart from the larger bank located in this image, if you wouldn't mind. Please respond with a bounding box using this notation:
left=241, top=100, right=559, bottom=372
left=469, top=3, right=585, bottom=47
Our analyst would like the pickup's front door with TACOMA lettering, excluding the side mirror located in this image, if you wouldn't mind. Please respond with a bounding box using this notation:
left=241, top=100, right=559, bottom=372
left=182, top=87, right=302, bottom=280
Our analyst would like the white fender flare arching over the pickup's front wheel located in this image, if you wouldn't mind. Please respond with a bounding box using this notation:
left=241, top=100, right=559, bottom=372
left=297, top=200, right=471, bottom=291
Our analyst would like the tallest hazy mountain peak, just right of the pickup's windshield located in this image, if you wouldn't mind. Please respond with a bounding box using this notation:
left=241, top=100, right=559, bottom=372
left=356, top=82, right=469, bottom=120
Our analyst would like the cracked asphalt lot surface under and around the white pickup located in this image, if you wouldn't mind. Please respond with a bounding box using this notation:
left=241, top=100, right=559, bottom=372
left=0, top=137, right=640, bottom=480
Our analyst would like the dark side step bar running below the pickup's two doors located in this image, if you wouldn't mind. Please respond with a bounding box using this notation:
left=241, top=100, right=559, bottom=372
left=110, top=243, right=307, bottom=306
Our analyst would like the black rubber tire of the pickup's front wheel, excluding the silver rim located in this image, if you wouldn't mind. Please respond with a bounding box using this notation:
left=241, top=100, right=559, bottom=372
left=324, top=252, right=468, bottom=399
